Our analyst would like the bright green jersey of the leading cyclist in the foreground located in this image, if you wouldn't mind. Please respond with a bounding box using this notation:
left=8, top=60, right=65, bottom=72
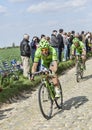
left=34, top=46, right=58, bottom=68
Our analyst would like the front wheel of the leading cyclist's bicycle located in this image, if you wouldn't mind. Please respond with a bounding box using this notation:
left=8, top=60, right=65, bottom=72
left=38, top=83, right=53, bottom=119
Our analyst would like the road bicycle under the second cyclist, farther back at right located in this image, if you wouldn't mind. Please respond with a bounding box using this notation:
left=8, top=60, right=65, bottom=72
left=76, top=55, right=84, bottom=82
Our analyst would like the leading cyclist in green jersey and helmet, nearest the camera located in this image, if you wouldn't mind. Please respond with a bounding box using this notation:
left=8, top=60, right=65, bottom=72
left=31, top=39, right=60, bottom=97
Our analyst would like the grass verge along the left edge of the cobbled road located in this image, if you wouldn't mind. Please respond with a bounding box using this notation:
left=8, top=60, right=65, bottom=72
left=0, top=52, right=92, bottom=103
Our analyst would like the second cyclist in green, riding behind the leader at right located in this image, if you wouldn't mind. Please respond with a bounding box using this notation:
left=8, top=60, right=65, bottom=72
left=71, top=38, right=86, bottom=68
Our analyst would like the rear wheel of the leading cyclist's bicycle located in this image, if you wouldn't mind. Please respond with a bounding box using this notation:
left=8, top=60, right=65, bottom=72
left=55, top=81, right=63, bottom=109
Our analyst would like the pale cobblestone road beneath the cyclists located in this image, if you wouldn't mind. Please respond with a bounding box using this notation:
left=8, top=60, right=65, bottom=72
left=0, top=59, right=92, bottom=130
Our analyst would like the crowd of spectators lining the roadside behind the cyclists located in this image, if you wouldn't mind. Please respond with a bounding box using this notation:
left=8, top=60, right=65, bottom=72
left=20, top=29, right=92, bottom=77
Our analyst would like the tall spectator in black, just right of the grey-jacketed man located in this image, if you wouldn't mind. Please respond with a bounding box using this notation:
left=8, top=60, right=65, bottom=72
left=57, top=29, right=64, bottom=62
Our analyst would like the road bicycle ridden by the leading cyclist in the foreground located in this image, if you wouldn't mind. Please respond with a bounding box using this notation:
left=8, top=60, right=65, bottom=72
left=34, top=70, right=63, bottom=119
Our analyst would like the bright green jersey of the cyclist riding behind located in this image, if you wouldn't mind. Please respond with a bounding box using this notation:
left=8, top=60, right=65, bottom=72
left=71, top=41, right=85, bottom=54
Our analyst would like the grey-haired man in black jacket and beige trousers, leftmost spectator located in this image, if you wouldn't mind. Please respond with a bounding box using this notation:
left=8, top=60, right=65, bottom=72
left=20, top=34, right=31, bottom=78
